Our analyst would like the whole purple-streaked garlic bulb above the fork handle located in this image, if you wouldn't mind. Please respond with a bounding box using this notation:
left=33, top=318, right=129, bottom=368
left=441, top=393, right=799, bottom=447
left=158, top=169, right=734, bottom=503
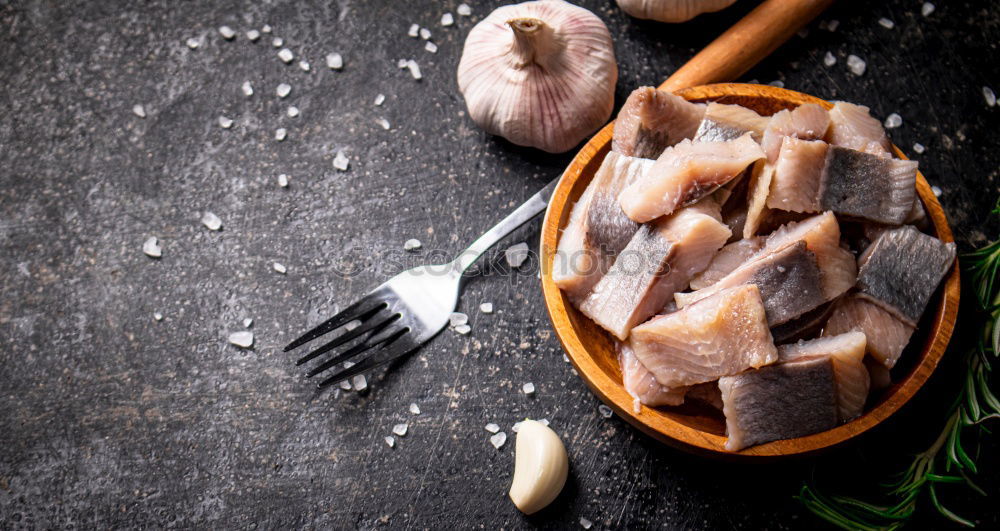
left=458, top=0, right=618, bottom=153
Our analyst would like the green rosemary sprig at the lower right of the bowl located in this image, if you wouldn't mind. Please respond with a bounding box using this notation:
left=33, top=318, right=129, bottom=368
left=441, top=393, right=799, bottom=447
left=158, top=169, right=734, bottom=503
left=796, top=219, right=1000, bottom=531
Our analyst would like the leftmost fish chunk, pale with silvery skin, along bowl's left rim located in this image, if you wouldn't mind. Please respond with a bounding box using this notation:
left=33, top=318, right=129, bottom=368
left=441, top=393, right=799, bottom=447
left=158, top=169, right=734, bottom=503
left=552, top=152, right=653, bottom=305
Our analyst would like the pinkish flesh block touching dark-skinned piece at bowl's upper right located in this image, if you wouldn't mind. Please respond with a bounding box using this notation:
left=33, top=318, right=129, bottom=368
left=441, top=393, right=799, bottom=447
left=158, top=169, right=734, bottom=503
left=767, top=137, right=829, bottom=212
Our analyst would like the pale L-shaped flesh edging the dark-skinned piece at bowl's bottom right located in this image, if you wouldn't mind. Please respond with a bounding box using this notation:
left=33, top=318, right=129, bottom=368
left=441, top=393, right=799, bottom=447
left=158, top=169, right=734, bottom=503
left=778, top=331, right=870, bottom=422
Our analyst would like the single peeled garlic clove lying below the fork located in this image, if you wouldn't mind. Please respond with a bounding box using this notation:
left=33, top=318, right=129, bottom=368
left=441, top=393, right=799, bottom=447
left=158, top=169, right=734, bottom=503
left=510, top=420, right=569, bottom=514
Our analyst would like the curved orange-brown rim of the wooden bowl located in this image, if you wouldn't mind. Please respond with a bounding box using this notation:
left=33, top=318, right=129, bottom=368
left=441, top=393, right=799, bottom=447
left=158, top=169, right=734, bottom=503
left=539, top=83, right=960, bottom=461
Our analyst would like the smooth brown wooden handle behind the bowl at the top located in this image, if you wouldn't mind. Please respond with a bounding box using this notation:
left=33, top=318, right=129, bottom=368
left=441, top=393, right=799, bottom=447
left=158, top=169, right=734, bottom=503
left=660, top=0, right=833, bottom=92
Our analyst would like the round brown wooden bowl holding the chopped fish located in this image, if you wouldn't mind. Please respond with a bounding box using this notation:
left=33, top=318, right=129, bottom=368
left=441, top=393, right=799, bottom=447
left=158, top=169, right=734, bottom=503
left=541, top=83, right=959, bottom=460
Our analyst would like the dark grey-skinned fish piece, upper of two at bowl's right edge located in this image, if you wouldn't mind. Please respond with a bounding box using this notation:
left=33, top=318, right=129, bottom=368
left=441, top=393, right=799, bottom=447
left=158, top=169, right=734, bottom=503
left=819, top=146, right=917, bottom=225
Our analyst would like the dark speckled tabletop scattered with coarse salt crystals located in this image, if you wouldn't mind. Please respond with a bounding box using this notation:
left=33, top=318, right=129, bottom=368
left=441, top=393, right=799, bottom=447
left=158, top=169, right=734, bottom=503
left=0, top=0, right=1000, bottom=529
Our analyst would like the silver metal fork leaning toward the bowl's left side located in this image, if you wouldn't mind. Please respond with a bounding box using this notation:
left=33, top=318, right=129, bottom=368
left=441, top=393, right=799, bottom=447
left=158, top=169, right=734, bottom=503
left=284, top=179, right=559, bottom=388
